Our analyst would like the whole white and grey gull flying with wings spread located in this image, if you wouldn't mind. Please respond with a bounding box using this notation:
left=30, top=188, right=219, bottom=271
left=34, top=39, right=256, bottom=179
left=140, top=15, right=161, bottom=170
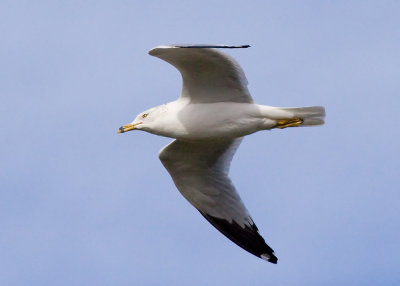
left=118, top=45, right=325, bottom=264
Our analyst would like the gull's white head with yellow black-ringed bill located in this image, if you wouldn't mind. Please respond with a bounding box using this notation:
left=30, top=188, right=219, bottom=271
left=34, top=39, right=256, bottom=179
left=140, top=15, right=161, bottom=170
left=117, top=105, right=164, bottom=133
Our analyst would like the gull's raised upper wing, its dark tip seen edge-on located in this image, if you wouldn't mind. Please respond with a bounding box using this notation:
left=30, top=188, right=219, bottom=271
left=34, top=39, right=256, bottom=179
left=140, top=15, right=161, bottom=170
left=149, top=45, right=253, bottom=103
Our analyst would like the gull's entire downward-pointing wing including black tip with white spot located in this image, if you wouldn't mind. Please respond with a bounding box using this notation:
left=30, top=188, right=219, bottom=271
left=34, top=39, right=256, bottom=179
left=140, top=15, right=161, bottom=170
left=159, top=138, right=277, bottom=263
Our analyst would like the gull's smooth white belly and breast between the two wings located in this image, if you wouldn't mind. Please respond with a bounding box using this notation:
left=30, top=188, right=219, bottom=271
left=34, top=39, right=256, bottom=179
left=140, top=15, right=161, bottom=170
left=150, top=102, right=275, bottom=140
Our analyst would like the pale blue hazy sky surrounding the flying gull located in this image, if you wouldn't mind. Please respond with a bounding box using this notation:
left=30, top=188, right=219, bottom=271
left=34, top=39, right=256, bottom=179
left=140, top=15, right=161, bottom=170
left=0, top=0, right=400, bottom=286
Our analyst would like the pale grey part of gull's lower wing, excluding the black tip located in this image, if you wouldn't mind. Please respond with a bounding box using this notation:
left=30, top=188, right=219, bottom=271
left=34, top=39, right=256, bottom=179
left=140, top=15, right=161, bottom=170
left=159, top=139, right=248, bottom=227
